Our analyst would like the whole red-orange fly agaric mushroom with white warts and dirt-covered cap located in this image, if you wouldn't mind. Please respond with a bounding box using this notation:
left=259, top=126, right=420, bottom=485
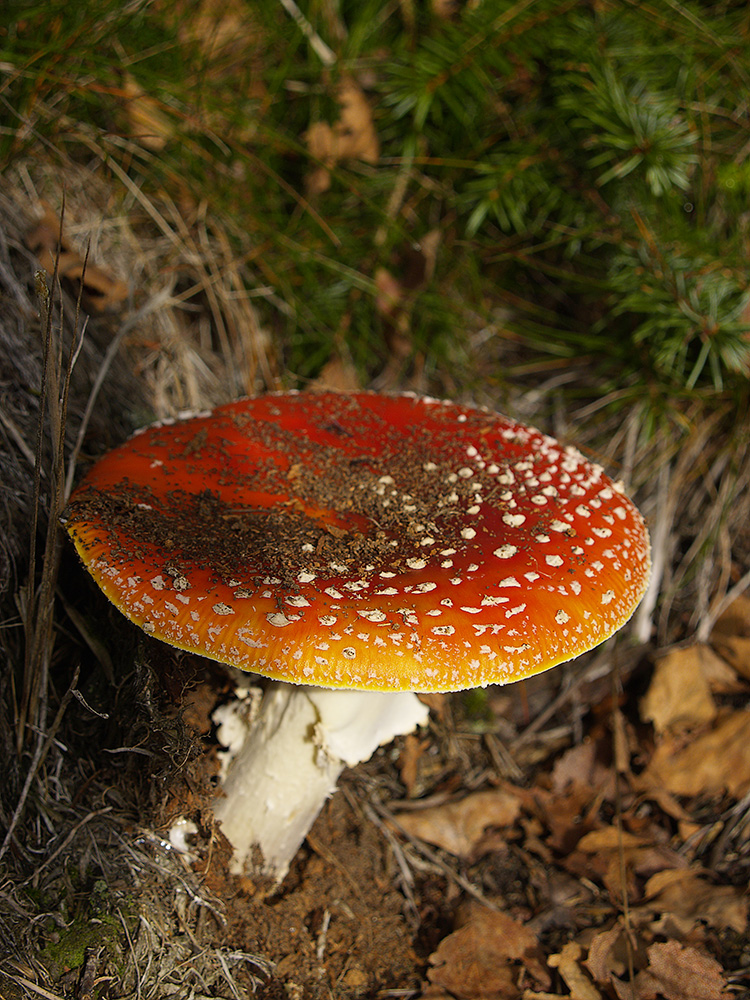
left=66, top=392, right=649, bottom=880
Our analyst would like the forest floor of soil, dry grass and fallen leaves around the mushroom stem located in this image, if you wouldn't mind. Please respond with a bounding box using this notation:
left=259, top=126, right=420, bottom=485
left=0, top=156, right=750, bottom=1000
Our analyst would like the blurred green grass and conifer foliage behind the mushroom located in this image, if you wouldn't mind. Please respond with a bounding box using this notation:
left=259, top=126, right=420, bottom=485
left=0, top=0, right=750, bottom=404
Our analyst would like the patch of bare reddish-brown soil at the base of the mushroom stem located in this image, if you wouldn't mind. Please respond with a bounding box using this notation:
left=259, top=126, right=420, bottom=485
left=201, top=794, right=424, bottom=1000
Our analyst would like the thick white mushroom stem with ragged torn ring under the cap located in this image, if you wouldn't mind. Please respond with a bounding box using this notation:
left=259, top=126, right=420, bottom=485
left=214, top=682, right=428, bottom=882
